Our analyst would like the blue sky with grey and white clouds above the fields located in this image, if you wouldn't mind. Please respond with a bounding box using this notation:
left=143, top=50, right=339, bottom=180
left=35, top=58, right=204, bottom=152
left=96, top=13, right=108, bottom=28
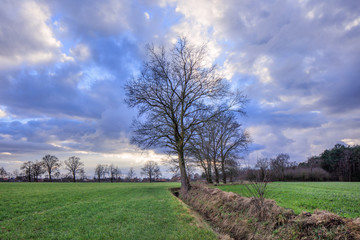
left=0, top=0, right=360, bottom=175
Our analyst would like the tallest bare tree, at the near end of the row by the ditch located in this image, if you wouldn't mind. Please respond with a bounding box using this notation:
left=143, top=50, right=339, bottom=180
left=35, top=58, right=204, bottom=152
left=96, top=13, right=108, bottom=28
left=125, top=38, right=244, bottom=191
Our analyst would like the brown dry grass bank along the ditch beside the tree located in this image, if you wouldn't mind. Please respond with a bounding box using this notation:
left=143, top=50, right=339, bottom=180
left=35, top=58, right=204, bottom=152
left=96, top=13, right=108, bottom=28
left=180, top=185, right=360, bottom=239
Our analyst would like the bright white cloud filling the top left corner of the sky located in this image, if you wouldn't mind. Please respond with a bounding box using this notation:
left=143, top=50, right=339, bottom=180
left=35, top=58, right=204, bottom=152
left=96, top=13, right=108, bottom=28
left=0, top=1, right=69, bottom=69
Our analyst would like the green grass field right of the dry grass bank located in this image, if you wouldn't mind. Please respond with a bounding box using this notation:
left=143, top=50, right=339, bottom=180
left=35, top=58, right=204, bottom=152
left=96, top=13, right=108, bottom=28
left=219, top=182, right=360, bottom=218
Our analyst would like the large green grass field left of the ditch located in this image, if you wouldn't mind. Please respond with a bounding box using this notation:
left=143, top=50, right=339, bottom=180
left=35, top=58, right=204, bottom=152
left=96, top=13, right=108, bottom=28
left=0, top=183, right=216, bottom=239
